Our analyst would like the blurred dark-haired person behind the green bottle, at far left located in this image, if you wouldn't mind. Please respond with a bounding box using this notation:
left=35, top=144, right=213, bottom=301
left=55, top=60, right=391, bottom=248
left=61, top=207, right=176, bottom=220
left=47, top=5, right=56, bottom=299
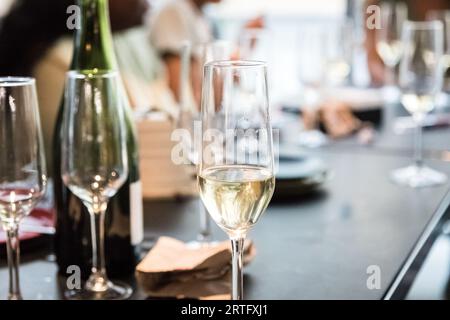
left=0, top=0, right=170, bottom=172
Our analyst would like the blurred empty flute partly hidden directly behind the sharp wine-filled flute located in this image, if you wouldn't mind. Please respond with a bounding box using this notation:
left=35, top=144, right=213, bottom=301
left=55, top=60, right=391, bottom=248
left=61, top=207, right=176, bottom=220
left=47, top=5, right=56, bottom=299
left=177, top=41, right=231, bottom=247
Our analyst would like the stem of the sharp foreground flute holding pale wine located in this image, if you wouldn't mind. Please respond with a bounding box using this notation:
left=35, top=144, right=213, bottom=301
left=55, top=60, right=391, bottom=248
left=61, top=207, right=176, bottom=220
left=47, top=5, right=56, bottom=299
left=231, top=237, right=245, bottom=300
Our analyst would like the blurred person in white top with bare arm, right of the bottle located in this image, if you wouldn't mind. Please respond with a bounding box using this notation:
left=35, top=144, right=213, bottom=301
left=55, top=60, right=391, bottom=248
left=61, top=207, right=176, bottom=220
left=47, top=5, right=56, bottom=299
left=150, top=0, right=264, bottom=101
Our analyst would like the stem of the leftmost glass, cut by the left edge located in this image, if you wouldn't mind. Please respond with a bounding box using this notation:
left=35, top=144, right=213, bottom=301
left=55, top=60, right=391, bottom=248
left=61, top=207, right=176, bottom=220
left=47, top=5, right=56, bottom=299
left=4, top=224, right=22, bottom=300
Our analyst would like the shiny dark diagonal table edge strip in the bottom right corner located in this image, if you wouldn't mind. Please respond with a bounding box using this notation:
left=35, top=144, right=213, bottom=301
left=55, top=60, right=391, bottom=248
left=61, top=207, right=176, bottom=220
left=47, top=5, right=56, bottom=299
left=382, top=186, right=450, bottom=300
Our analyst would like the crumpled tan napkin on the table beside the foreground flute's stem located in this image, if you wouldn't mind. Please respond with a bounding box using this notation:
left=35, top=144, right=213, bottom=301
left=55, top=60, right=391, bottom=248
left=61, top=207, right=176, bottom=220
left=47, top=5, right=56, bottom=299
left=136, top=237, right=256, bottom=300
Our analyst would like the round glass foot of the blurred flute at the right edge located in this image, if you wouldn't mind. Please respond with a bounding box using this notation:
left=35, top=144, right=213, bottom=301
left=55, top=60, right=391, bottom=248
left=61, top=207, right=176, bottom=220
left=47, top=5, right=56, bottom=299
left=390, top=165, right=447, bottom=188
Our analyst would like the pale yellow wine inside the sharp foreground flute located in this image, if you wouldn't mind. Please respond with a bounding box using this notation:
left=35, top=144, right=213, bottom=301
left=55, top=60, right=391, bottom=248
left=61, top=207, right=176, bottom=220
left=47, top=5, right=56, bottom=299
left=198, top=165, right=275, bottom=235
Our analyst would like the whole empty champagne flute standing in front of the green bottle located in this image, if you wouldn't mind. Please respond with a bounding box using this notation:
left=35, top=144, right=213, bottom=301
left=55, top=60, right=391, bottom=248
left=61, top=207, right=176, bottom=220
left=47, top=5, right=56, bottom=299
left=61, top=70, right=132, bottom=300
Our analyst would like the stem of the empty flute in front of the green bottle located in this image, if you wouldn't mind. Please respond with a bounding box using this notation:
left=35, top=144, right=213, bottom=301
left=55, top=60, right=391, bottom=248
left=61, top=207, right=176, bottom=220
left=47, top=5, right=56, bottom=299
left=86, top=202, right=108, bottom=292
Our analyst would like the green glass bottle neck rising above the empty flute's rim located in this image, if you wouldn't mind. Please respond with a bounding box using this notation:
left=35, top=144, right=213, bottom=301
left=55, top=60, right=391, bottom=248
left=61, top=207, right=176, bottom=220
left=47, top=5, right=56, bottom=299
left=71, top=0, right=117, bottom=70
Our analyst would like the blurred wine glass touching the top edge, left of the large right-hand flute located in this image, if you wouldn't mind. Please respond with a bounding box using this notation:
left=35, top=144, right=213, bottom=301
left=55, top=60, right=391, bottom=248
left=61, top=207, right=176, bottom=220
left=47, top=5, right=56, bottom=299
left=375, top=1, right=408, bottom=102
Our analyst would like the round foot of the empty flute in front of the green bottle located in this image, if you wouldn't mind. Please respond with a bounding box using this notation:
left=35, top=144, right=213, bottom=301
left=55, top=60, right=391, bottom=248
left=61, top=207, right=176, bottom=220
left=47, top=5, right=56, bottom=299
left=64, top=281, right=133, bottom=300
